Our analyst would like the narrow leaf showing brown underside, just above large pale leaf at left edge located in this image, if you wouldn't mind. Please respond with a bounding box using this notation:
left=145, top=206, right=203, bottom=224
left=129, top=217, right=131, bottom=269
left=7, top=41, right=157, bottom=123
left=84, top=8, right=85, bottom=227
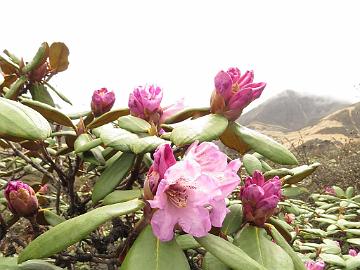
left=21, top=98, right=76, bottom=129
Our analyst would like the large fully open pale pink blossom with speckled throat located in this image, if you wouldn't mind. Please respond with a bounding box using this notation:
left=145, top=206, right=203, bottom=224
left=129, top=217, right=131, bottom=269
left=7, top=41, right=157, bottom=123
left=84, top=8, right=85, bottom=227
left=148, top=142, right=240, bottom=241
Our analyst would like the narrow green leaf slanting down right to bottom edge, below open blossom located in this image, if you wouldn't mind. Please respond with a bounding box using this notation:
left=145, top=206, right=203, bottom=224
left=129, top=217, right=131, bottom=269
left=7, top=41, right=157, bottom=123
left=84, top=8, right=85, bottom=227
left=195, top=234, right=268, bottom=270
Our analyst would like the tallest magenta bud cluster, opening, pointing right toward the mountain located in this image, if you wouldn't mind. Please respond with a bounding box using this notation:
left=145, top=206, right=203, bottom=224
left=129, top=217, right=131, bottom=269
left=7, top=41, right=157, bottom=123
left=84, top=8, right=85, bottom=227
left=210, top=67, right=266, bottom=121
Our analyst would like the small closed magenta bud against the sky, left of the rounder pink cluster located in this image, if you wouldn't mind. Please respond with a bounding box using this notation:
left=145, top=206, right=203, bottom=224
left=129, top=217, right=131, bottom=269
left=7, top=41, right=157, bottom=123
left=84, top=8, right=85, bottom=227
left=91, top=88, right=115, bottom=117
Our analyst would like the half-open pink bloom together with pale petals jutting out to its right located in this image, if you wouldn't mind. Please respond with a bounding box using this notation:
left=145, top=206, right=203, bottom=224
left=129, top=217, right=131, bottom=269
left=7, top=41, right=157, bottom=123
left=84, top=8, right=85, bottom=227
left=128, top=85, right=184, bottom=125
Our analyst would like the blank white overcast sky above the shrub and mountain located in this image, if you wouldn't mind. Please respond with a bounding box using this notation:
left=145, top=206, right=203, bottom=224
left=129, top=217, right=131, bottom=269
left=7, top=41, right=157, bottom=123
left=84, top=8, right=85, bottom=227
left=0, top=0, right=360, bottom=112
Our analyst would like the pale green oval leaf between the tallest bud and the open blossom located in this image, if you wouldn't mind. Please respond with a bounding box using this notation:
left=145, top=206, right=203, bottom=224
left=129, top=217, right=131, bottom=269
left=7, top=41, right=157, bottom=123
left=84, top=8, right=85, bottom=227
left=170, top=114, right=228, bottom=146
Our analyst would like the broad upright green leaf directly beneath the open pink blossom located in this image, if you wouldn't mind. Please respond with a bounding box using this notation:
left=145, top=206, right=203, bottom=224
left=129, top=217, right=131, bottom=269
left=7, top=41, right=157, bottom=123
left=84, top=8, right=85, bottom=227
left=120, top=225, right=190, bottom=270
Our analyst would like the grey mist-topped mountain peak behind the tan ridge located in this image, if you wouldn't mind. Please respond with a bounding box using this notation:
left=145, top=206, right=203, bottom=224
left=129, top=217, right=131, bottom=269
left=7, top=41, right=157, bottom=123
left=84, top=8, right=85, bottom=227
left=239, top=90, right=349, bottom=132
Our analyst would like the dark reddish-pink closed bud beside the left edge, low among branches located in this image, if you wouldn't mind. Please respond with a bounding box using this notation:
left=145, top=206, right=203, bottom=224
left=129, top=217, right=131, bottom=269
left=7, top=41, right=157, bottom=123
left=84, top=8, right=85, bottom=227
left=4, top=181, right=39, bottom=217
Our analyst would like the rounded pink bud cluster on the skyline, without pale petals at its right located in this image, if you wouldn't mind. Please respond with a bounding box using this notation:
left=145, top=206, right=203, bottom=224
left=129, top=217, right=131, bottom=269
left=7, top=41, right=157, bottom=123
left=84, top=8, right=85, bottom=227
left=128, top=85, right=163, bottom=122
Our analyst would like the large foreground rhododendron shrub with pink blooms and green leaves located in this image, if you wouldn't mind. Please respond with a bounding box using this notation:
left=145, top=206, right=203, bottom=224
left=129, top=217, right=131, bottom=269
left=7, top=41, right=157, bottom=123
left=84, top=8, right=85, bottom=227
left=0, top=42, right=326, bottom=270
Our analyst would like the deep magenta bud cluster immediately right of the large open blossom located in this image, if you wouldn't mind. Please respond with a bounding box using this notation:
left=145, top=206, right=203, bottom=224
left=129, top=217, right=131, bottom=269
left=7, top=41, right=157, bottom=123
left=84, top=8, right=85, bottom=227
left=240, top=171, right=281, bottom=226
